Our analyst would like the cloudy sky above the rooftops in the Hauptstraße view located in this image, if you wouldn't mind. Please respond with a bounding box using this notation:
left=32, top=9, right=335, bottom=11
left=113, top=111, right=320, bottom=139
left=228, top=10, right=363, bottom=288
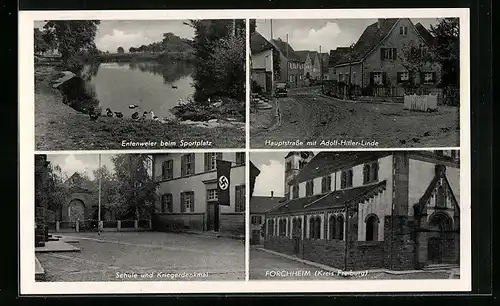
left=256, top=18, right=438, bottom=53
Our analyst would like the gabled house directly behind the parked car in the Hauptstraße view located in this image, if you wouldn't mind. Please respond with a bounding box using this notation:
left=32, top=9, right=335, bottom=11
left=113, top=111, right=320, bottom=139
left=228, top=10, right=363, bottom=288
left=271, top=38, right=305, bottom=88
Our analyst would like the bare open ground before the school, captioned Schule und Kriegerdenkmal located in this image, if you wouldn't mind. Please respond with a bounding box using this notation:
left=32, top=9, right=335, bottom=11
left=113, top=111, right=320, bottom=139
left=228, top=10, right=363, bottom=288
left=36, top=232, right=245, bottom=282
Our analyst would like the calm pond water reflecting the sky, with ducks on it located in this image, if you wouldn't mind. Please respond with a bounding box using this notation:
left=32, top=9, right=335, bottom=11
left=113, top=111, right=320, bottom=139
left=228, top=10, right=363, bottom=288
left=70, top=62, right=194, bottom=118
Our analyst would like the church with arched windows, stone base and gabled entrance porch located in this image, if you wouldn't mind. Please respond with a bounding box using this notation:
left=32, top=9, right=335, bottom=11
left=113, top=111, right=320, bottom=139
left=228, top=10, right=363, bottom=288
left=264, top=150, right=460, bottom=270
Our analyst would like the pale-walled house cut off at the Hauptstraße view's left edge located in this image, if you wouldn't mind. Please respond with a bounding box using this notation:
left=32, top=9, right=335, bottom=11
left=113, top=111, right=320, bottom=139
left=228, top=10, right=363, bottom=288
left=250, top=32, right=279, bottom=94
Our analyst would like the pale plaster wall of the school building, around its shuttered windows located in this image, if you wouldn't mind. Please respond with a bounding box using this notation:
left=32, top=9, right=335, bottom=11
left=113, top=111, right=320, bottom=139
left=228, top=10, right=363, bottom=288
left=154, top=153, right=245, bottom=214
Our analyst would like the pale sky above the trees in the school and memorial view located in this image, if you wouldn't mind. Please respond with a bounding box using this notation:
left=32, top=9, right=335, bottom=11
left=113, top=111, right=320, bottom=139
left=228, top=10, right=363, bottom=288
left=47, top=154, right=114, bottom=180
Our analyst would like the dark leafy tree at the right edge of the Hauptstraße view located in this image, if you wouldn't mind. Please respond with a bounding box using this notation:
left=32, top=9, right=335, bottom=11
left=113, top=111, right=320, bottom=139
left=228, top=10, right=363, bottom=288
left=430, top=18, right=460, bottom=86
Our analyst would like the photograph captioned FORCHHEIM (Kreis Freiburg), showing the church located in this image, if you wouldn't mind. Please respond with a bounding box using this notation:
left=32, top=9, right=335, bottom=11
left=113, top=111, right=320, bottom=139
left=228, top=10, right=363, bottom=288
left=249, top=150, right=460, bottom=281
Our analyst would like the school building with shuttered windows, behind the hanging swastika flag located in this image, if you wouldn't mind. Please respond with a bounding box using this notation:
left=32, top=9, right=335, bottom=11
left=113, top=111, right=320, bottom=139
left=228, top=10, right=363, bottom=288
left=152, top=152, right=246, bottom=236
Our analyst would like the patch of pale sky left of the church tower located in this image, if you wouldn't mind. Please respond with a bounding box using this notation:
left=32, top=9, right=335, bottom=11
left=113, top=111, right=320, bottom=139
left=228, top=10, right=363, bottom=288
left=250, top=151, right=288, bottom=197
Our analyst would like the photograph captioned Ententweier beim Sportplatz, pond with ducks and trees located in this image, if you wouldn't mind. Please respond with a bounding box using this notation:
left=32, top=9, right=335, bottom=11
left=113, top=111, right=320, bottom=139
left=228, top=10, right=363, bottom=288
left=33, top=19, right=246, bottom=151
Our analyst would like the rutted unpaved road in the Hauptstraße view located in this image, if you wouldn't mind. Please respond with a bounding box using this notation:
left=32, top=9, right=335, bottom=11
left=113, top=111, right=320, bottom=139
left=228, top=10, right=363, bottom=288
left=250, top=87, right=460, bottom=148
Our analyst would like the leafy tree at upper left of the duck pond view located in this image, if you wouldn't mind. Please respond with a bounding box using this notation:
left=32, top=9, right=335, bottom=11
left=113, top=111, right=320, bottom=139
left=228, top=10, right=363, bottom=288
left=43, top=20, right=100, bottom=63
